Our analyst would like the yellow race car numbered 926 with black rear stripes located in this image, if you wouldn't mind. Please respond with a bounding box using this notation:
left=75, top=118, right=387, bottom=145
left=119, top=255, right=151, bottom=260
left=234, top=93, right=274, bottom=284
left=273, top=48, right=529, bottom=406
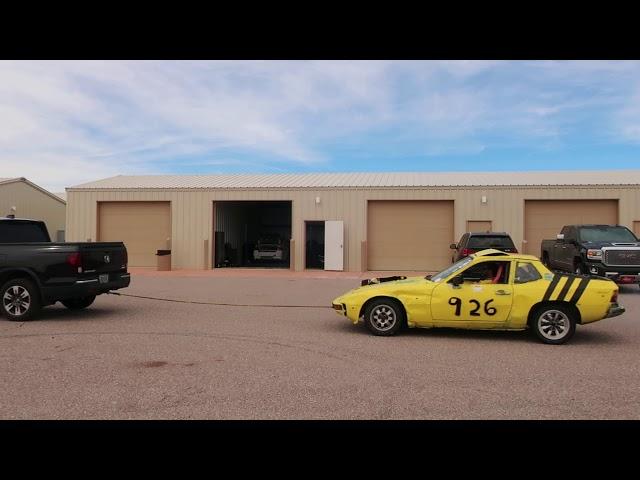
left=333, top=249, right=625, bottom=344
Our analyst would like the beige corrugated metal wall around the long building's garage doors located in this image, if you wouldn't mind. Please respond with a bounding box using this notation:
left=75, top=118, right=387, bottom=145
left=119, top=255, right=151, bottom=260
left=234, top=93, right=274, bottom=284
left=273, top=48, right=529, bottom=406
left=67, top=186, right=640, bottom=271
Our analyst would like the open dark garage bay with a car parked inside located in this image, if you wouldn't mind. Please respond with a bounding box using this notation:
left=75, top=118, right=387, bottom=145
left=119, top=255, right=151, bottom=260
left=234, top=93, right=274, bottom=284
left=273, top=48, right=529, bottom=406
left=213, top=201, right=292, bottom=268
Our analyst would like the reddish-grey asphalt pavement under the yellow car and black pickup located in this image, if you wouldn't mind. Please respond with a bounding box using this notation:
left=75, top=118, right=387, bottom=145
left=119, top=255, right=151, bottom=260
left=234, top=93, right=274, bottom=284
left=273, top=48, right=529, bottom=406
left=0, top=276, right=640, bottom=419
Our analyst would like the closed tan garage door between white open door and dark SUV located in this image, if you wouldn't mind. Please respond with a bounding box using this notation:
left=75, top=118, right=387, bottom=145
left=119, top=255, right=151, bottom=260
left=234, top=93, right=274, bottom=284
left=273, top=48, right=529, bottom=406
left=367, top=200, right=454, bottom=271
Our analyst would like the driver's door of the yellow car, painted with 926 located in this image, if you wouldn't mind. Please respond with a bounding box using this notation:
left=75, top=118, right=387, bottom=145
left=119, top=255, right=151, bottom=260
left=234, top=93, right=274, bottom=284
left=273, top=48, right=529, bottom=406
left=431, top=258, right=513, bottom=328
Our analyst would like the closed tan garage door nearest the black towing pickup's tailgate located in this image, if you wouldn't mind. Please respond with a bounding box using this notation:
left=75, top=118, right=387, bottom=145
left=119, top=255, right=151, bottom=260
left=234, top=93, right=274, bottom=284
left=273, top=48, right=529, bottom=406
left=98, top=202, right=171, bottom=267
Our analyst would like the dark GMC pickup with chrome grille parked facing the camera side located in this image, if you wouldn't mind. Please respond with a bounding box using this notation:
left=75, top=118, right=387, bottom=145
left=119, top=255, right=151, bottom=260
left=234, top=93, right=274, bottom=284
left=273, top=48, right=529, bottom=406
left=540, top=225, right=640, bottom=284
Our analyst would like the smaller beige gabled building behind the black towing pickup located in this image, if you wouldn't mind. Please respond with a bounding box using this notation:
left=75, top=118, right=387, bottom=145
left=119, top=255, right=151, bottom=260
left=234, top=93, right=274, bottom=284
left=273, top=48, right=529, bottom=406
left=0, top=182, right=67, bottom=241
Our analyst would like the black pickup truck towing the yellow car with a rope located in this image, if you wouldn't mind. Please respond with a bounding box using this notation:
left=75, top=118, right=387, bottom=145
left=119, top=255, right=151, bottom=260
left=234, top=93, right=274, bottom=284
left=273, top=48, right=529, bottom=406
left=0, top=218, right=131, bottom=321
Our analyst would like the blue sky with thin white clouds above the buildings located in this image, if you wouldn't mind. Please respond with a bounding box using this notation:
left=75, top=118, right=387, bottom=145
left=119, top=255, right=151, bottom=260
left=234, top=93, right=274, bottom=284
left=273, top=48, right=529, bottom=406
left=0, top=61, right=640, bottom=191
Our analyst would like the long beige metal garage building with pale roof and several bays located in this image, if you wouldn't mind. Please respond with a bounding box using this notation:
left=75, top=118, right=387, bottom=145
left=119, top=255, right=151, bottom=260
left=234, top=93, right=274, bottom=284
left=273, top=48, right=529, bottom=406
left=67, top=170, right=640, bottom=271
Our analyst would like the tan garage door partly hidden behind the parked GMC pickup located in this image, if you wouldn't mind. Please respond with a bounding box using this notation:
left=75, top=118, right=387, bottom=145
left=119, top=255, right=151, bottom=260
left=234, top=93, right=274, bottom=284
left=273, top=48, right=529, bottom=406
left=523, top=200, right=618, bottom=257
